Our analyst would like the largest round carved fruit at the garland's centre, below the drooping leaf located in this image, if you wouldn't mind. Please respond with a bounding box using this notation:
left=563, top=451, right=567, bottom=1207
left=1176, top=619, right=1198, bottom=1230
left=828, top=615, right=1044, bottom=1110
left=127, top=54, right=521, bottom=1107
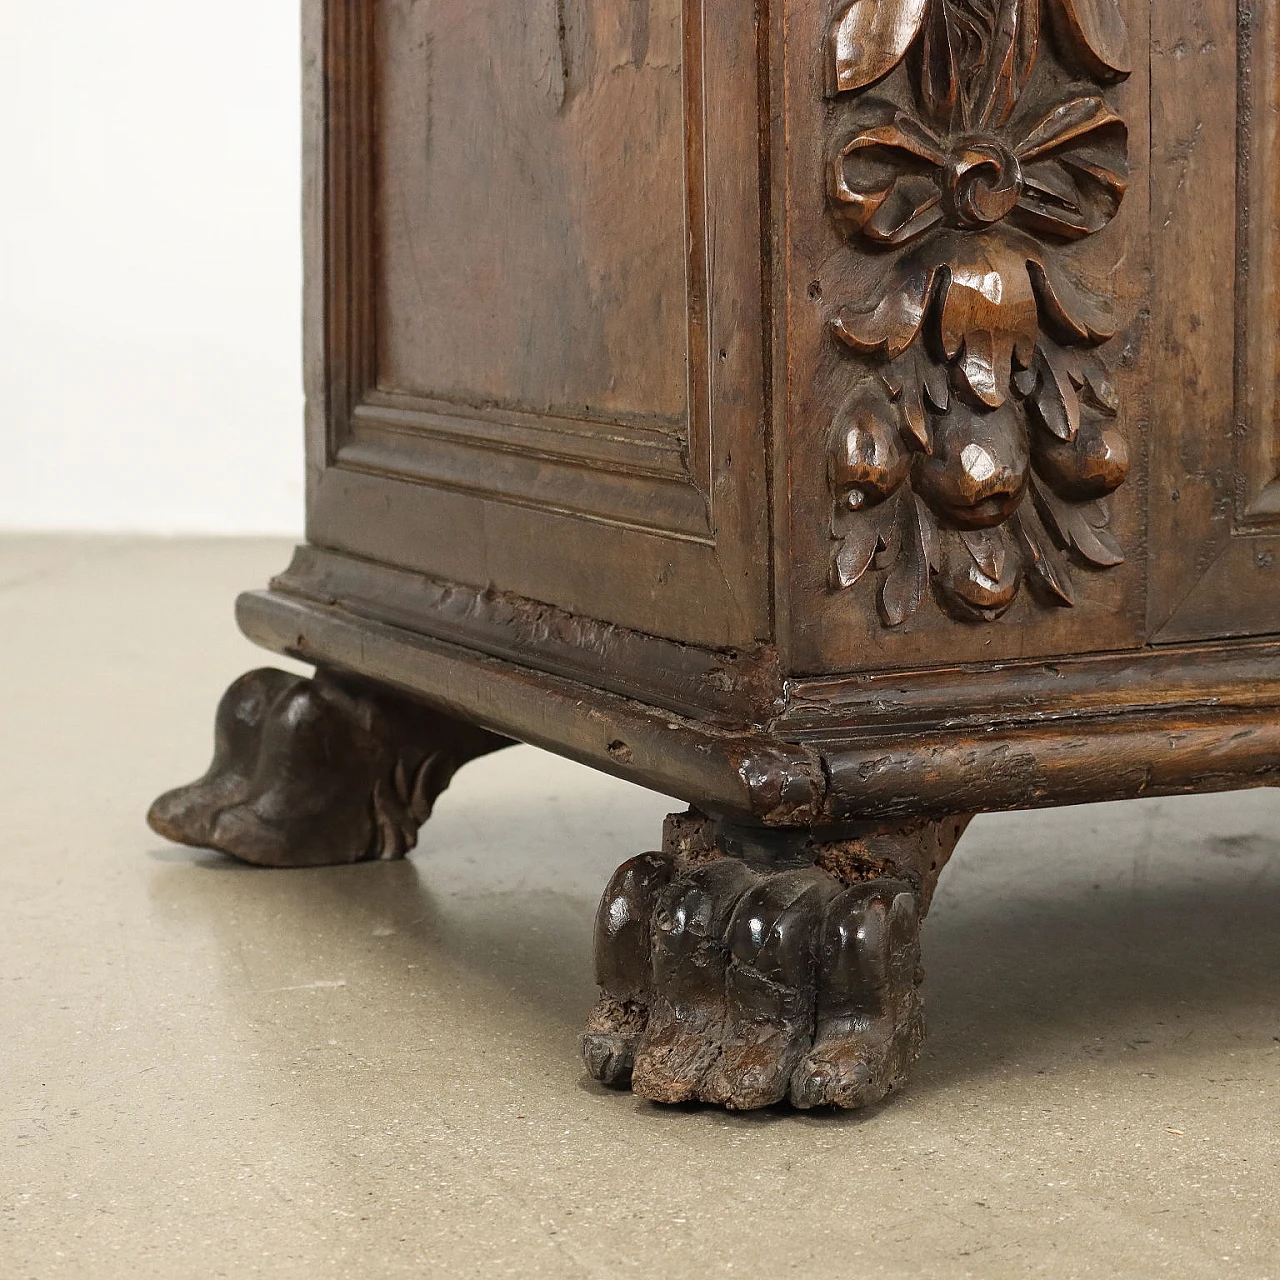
left=916, top=401, right=1030, bottom=529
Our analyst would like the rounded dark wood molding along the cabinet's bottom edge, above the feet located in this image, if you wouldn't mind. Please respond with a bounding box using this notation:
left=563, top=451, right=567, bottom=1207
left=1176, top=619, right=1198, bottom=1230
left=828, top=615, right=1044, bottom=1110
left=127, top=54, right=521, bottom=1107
left=238, top=590, right=1280, bottom=835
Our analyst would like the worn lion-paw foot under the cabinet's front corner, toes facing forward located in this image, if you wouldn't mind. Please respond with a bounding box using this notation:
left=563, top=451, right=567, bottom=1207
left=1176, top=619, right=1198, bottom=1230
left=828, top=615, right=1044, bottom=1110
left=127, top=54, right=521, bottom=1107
left=582, top=813, right=968, bottom=1110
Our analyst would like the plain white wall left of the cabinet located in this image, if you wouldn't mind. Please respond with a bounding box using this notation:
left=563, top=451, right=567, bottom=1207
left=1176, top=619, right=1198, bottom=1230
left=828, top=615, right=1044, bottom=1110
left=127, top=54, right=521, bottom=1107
left=0, top=0, right=302, bottom=534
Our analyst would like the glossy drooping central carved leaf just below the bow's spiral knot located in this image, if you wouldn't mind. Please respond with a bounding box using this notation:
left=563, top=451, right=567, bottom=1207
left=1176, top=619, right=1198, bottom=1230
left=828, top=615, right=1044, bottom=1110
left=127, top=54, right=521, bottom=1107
left=938, top=236, right=1039, bottom=408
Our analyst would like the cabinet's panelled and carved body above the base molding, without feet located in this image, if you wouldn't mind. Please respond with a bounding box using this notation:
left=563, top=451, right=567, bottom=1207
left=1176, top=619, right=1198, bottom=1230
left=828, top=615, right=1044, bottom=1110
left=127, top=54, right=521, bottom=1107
left=296, top=0, right=1280, bottom=680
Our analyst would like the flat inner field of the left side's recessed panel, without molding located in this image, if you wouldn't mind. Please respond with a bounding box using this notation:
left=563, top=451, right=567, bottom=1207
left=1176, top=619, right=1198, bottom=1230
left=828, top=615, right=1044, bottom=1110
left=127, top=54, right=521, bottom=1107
left=374, top=0, right=689, bottom=426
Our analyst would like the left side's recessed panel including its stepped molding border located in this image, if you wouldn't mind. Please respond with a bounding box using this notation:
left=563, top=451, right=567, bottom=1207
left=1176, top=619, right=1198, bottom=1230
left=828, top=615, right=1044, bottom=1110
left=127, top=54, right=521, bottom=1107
left=318, top=0, right=710, bottom=540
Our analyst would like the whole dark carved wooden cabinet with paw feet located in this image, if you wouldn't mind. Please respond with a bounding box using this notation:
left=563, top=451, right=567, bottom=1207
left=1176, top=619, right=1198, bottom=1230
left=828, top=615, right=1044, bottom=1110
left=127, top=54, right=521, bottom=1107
left=151, top=0, right=1280, bottom=1107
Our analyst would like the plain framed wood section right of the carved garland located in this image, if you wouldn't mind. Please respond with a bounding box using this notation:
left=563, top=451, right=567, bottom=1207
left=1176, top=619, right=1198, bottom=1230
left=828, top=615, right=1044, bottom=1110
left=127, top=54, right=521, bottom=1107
left=1149, top=0, right=1280, bottom=643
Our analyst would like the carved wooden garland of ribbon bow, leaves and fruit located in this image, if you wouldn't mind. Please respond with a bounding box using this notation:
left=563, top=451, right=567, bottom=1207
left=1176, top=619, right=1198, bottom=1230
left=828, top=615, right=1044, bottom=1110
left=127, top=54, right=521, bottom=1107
left=828, top=0, right=1129, bottom=626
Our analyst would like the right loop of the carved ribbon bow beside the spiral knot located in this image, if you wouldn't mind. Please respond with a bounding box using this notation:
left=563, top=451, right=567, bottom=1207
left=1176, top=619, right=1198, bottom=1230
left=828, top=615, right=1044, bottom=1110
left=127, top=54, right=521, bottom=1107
left=1014, top=97, right=1129, bottom=239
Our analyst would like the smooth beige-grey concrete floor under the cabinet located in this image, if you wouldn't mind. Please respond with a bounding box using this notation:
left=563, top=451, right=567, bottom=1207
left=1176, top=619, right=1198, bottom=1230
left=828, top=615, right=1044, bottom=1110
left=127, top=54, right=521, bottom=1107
left=0, top=539, right=1280, bottom=1280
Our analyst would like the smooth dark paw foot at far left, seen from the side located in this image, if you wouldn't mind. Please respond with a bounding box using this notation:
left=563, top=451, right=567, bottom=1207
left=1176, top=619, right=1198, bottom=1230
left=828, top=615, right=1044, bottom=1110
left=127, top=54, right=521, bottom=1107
left=147, top=668, right=508, bottom=867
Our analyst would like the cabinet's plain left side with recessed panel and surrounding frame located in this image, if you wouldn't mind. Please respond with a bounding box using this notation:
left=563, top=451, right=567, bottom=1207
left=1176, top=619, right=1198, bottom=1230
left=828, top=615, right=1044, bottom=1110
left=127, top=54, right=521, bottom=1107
left=305, top=0, right=771, bottom=646
